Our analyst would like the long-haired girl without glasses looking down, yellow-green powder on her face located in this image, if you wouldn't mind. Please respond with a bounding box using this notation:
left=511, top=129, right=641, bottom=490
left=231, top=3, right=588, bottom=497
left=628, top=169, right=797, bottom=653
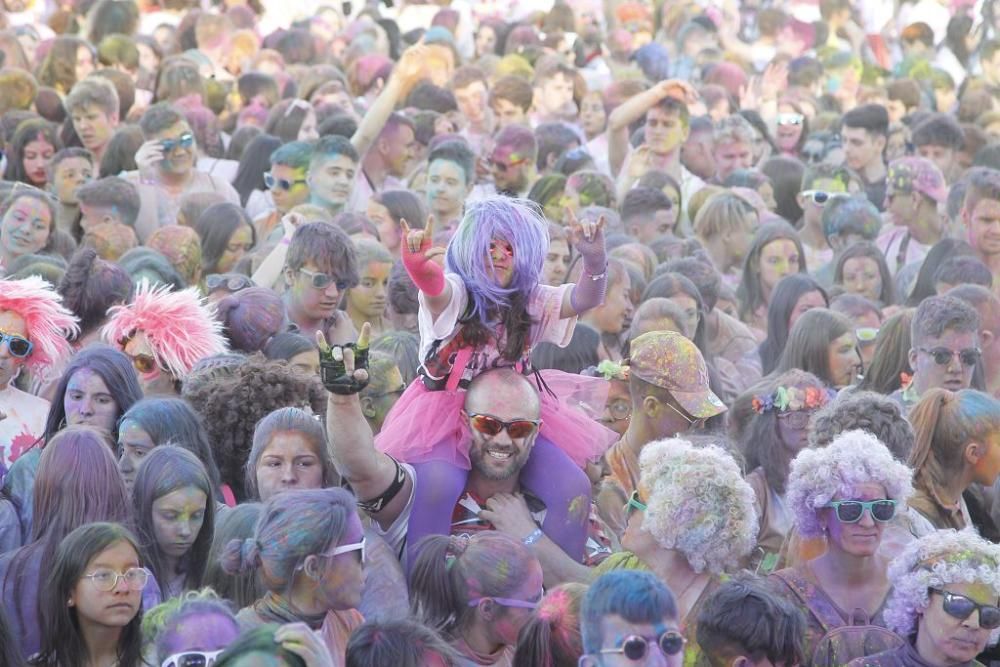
left=132, top=445, right=215, bottom=606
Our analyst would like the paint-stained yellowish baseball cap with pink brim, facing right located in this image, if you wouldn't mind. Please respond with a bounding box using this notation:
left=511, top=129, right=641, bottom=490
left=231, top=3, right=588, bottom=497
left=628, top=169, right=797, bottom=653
left=629, top=331, right=726, bottom=419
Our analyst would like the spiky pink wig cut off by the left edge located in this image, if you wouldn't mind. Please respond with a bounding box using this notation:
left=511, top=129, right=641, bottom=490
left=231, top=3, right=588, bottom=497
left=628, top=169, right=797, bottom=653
left=0, top=276, right=80, bottom=376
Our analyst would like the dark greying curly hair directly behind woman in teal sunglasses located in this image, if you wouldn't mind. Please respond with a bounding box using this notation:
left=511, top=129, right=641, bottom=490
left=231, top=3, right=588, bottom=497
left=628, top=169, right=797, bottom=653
left=809, top=391, right=915, bottom=463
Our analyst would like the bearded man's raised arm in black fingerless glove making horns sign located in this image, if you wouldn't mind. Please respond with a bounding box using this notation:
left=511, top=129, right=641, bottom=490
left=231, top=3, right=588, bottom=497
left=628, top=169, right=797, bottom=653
left=316, top=322, right=413, bottom=530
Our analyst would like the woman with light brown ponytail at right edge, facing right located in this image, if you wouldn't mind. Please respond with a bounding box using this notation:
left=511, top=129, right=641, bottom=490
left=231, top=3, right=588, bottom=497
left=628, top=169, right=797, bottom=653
left=906, top=389, right=1000, bottom=537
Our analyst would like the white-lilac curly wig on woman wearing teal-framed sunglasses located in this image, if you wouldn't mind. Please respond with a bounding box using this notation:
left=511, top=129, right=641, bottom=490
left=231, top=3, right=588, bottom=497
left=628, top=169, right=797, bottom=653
left=786, top=430, right=913, bottom=537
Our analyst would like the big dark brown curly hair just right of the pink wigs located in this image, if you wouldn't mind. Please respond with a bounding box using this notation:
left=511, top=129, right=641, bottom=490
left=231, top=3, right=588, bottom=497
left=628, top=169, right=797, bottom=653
left=183, top=354, right=326, bottom=502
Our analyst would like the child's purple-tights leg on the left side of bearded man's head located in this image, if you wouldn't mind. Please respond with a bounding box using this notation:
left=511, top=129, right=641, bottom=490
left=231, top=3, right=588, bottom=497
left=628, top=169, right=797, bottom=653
left=406, top=461, right=469, bottom=572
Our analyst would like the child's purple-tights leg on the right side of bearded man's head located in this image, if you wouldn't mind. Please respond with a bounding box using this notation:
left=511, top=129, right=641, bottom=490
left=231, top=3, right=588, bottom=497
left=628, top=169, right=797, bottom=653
left=521, top=435, right=590, bottom=562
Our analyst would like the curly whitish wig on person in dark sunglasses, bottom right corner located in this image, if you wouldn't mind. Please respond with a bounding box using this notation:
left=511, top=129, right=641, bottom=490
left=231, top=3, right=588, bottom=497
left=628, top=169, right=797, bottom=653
left=885, top=529, right=1000, bottom=637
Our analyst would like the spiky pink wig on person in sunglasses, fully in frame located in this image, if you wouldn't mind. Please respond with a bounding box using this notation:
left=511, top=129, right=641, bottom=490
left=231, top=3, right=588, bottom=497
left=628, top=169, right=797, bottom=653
left=102, top=280, right=226, bottom=378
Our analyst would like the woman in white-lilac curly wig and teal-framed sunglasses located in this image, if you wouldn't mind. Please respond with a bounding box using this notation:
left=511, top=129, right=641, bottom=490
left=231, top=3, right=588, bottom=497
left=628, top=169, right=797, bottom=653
left=767, top=431, right=913, bottom=665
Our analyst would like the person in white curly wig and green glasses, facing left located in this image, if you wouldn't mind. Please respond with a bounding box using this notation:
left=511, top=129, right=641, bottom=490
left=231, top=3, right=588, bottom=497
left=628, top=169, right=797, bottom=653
left=595, top=438, right=757, bottom=664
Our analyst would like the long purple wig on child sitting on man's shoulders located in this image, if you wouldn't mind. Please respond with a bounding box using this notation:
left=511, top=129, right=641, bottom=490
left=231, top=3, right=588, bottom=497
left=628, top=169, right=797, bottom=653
left=445, top=197, right=549, bottom=325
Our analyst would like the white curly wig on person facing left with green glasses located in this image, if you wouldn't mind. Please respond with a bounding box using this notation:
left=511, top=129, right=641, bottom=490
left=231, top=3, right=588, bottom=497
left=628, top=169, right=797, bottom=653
left=639, top=438, right=758, bottom=574
